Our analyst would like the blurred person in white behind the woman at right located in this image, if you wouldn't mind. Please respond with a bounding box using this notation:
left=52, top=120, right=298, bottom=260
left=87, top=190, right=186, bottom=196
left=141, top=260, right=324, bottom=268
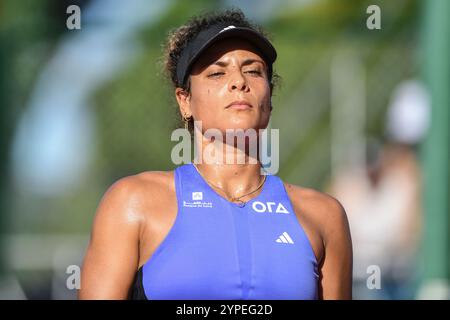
left=330, top=81, right=429, bottom=299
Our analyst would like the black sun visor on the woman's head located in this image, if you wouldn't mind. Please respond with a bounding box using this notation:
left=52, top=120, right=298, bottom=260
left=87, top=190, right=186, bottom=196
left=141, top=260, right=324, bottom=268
left=177, top=23, right=277, bottom=87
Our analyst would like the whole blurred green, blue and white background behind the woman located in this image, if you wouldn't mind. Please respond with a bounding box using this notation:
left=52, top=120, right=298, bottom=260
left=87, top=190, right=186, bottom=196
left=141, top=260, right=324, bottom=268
left=0, top=0, right=450, bottom=299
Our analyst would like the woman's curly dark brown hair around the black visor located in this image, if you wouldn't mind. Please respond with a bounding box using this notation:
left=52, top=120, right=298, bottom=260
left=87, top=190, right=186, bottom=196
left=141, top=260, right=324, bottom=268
left=163, top=8, right=279, bottom=133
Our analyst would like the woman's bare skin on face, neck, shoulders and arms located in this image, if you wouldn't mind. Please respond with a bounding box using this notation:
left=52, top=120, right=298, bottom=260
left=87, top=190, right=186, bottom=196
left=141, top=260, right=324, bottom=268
left=78, top=39, right=352, bottom=299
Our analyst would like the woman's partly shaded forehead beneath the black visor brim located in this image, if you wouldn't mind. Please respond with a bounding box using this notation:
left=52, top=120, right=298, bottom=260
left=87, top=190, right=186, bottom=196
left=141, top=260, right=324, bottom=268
left=192, top=38, right=264, bottom=73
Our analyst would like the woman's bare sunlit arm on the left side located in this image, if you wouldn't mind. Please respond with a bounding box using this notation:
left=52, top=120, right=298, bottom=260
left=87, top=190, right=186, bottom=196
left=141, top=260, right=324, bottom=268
left=78, top=177, right=142, bottom=299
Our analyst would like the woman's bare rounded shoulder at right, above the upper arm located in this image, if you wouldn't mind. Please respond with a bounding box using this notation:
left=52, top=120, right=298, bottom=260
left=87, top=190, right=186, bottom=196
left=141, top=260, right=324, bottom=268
left=285, top=183, right=348, bottom=239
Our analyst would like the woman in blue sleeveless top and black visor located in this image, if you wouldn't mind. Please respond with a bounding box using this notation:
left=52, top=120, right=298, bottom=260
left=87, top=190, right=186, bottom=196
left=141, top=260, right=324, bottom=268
left=79, top=10, right=352, bottom=300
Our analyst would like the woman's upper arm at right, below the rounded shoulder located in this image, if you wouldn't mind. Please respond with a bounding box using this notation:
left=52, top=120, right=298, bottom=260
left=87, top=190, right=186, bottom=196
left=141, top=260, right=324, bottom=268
left=319, top=196, right=353, bottom=300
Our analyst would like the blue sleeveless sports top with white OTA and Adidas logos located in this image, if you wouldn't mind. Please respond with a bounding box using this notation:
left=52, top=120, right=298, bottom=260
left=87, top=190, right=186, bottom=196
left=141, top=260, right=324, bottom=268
left=132, top=163, right=319, bottom=300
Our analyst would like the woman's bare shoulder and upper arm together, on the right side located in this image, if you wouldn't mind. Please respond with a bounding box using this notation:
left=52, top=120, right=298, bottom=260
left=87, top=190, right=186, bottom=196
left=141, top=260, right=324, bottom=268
left=286, top=184, right=353, bottom=299
